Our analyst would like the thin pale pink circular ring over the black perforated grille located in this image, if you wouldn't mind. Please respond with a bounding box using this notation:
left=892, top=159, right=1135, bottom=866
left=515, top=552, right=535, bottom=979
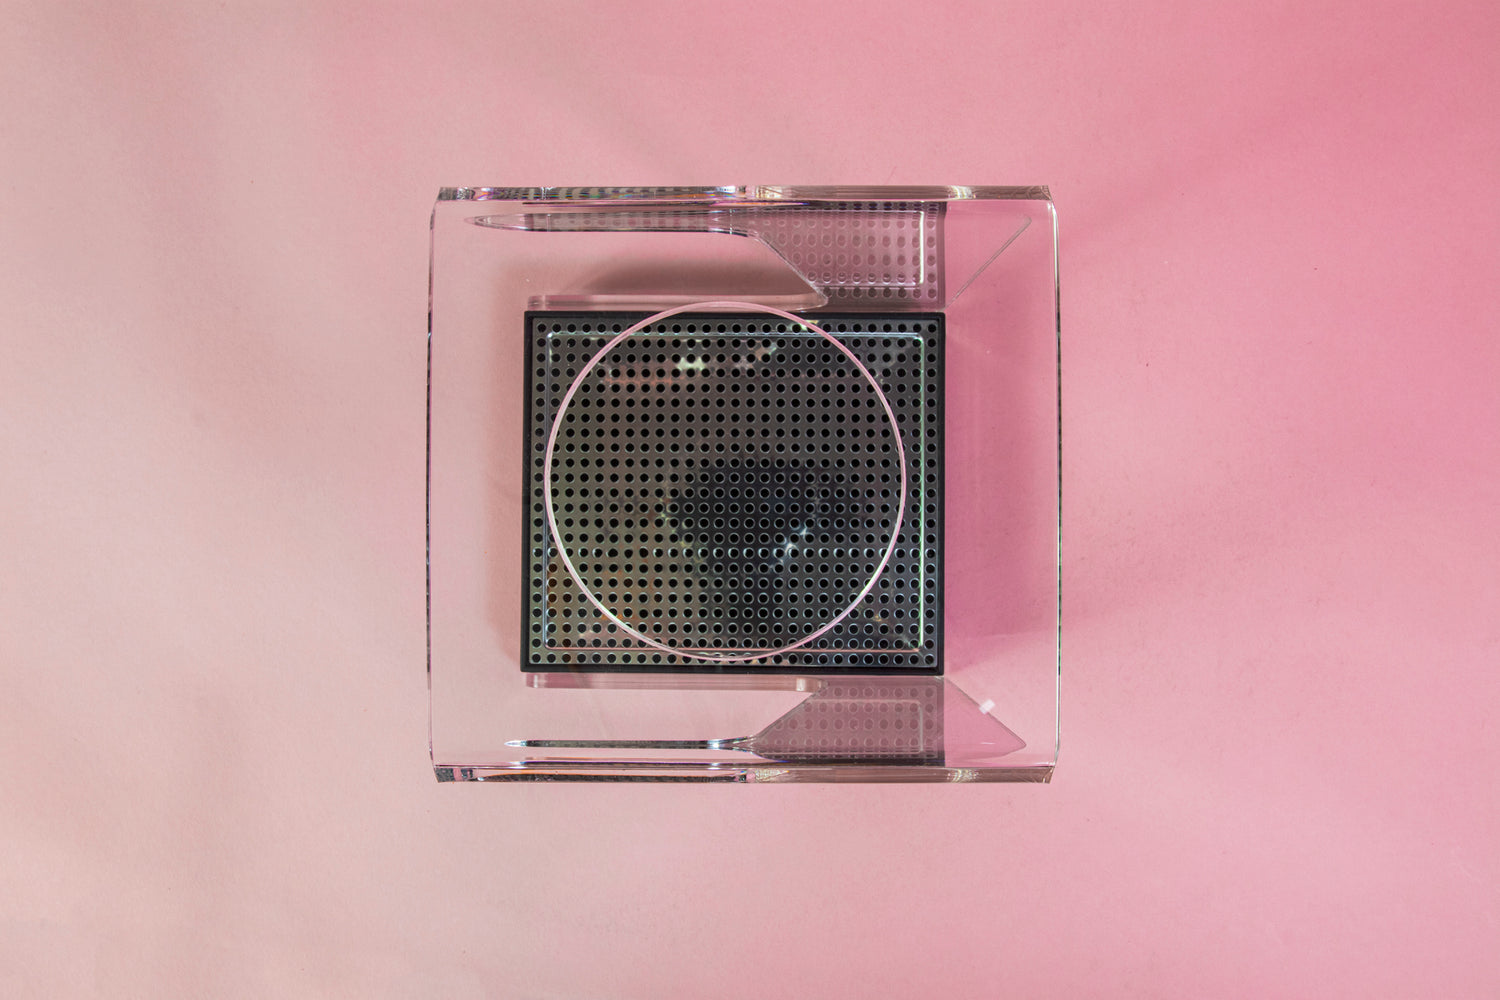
left=542, top=300, right=908, bottom=663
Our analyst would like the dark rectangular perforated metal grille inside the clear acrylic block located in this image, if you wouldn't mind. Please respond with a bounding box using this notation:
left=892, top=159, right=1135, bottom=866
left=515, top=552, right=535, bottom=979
left=522, top=312, right=944, bottom=673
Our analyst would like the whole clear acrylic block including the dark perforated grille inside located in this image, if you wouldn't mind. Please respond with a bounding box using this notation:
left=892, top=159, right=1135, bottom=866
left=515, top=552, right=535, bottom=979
left=428, top=187, right=1061, bottom=783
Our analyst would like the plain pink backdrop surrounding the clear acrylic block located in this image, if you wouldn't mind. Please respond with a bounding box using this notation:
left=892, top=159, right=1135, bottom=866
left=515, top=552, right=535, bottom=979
left=0, top=3, right=1500, bottom=999
